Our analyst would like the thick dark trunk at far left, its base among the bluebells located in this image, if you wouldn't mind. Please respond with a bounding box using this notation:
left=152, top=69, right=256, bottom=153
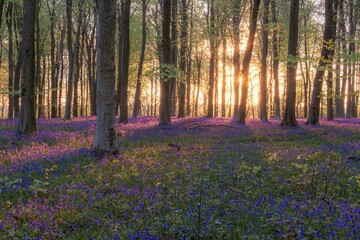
left=18, top=0, right=37, bottom=134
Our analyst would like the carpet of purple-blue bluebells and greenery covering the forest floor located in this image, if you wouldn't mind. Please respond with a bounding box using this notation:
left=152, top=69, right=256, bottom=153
left=0, top=117, right=360, bottom=239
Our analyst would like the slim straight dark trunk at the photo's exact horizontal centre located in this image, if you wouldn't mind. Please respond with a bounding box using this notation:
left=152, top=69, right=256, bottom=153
left=178, top=0, right=190, bottom=118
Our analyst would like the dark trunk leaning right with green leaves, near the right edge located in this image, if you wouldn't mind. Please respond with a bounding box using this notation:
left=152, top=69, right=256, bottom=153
left=306, top=0, right=338, bottom=125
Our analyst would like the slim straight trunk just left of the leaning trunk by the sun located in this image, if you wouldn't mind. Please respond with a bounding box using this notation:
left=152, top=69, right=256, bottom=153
left=233, top=0, right=241, bottom=119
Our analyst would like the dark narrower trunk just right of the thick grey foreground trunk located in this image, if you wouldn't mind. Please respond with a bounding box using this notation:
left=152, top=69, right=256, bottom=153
left=119, top=0, right=131, bottom=123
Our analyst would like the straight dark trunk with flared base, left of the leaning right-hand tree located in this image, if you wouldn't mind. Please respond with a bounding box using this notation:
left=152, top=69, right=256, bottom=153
left=280, top=0, right=299, bottom=126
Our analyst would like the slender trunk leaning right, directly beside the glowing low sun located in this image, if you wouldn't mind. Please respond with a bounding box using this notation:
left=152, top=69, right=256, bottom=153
left=237, top=0, right=260, bottom=124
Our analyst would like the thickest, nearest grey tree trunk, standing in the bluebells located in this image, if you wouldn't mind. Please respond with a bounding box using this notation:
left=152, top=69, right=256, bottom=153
left=94, top=0, right=118, bottom=154
